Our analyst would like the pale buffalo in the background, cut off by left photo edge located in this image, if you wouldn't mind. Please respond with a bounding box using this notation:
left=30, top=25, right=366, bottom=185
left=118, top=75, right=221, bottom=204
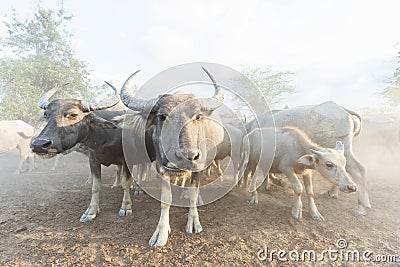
left=0, top=120, right=35, bottom=174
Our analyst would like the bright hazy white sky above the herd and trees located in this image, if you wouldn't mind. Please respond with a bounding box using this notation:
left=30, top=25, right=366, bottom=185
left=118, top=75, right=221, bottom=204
left=0, top=0, right=400, bottom=109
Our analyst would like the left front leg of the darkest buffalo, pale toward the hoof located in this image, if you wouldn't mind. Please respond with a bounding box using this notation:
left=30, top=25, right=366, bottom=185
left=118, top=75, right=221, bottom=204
left=80, top=157, right=101, bottom=222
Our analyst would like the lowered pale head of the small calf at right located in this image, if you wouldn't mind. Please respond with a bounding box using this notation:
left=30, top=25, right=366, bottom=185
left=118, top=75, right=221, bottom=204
left=297, top=141, right=358, bottom=193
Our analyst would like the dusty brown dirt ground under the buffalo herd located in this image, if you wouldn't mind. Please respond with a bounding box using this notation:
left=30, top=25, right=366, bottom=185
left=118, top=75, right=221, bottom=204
left=0, top=150, right=400, bottom=266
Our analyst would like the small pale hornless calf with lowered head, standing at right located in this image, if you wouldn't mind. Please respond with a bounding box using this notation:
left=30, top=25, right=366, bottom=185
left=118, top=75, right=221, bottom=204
left=243, top=127, right=357, bottom=221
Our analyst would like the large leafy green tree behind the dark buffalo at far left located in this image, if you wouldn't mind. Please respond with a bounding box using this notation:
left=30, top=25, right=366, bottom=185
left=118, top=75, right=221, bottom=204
left=0, top=6, right=93, bottom=124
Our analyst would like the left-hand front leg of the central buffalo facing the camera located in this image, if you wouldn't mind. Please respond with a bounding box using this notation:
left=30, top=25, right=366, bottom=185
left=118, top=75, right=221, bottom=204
left=149, top=176, right=172, bottom=246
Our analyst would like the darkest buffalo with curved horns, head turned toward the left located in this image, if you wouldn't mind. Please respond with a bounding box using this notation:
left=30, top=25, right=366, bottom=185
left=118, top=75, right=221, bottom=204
left=31, top=83, right=154, bottom=222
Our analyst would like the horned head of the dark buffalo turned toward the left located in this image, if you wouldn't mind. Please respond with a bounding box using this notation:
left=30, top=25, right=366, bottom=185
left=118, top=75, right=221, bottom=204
left=31, top=85, right=119, bottom=158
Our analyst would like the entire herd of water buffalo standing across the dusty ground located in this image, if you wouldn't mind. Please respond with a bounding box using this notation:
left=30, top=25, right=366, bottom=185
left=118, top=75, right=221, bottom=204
left=0, top=68, right=400, bottom=246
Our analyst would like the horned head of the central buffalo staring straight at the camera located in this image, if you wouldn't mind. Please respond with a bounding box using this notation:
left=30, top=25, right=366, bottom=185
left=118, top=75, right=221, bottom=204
left=121, top=68, right=224, bottom=175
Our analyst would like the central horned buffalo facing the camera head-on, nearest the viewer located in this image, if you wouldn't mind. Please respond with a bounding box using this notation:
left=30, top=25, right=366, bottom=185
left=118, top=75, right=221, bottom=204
left=121, top=68, right=224, bottom=246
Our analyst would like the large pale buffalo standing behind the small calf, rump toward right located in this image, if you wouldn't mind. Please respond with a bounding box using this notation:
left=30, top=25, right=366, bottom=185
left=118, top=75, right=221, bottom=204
left=246, top=101, right=371, bottom=215
